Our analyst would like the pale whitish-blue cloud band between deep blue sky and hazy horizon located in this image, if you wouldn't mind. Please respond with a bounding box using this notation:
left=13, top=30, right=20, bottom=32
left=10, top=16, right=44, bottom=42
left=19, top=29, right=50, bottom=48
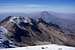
left=0, top=4, right=75, bottom=13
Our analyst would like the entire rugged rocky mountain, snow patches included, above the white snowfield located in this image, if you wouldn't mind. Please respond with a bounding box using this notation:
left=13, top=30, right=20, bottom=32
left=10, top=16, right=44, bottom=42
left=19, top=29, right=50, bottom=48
left=0, top=16, right=75, bottom=48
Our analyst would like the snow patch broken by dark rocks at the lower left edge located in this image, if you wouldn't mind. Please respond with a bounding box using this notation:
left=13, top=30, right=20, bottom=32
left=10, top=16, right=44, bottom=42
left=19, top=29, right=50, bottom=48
left=0, top=26, right=16, bottom=48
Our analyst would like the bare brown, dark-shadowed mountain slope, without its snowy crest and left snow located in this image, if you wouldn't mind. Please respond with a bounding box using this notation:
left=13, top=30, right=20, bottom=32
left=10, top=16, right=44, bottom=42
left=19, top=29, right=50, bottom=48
left=1, top=17, right=75, bottom=47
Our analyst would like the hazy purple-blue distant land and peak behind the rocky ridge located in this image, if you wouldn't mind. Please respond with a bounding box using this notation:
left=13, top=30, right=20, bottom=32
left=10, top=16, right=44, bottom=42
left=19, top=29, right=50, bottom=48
left=0, top=11, right=75, bottom=34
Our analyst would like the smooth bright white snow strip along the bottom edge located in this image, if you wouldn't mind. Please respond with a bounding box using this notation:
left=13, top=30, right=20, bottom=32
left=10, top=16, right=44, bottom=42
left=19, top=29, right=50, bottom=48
left=0, top=44, right=75, bottom=50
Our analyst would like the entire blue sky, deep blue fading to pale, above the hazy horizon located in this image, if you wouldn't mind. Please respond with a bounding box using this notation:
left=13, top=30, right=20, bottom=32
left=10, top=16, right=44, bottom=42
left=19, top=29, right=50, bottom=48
left=0, top=0, right=75, bottom=13
